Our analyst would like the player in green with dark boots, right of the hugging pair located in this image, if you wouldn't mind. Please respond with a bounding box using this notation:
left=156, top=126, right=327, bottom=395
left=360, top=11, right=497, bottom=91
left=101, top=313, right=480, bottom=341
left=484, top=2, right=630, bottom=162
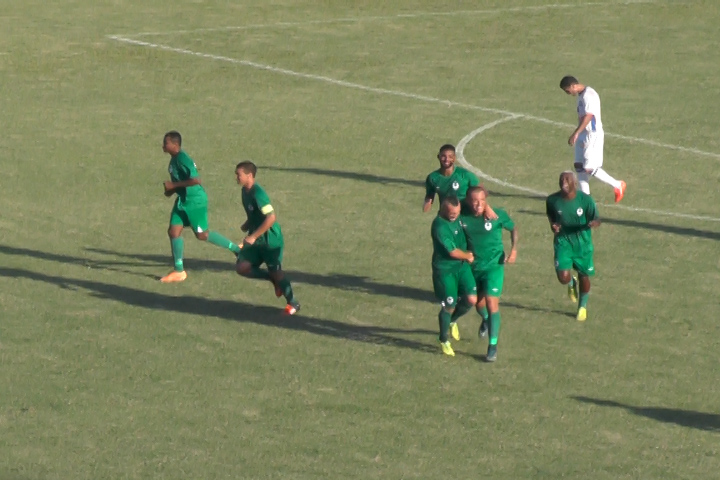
left=460, top=187, right=518, bottom=362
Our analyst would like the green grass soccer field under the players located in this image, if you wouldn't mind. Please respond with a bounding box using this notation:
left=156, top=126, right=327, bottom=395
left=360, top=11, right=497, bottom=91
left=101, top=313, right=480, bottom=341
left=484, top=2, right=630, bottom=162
left=0, top=0, right=720, bottom=480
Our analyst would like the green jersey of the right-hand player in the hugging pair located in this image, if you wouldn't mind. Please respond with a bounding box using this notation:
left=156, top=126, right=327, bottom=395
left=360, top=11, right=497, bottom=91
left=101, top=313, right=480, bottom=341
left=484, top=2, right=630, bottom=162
left=460, top=208, right=515, bottom=271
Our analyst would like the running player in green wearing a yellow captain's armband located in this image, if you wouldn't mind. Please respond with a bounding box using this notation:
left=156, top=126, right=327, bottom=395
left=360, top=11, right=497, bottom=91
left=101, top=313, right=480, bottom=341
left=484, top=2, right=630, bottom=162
left=235, top=161, right=300, bottom=315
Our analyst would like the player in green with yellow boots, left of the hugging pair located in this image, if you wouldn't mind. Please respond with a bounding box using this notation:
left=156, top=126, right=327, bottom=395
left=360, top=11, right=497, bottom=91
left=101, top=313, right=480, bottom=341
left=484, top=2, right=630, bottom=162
left=430, top=197, right=477, bottom=356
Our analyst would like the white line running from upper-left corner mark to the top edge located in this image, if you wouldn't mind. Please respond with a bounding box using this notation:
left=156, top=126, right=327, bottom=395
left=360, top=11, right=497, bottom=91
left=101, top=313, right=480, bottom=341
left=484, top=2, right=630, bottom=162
left=118, top=0, right=657, bottom=38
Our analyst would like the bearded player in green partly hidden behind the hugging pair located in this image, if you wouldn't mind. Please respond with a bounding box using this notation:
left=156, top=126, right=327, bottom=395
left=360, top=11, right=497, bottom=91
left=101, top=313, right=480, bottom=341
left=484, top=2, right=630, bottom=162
left=423, top=144, right=480, bottom=212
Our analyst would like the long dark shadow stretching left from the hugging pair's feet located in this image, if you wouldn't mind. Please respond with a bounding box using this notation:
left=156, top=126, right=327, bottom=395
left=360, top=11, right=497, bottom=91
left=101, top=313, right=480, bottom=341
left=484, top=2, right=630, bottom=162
left=0, top=267, right=466, bottom=358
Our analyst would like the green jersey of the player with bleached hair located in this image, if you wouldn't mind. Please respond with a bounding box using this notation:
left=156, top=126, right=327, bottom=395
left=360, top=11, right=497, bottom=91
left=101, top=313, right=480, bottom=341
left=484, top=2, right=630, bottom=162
left=545, top=192, right=598, bottom=246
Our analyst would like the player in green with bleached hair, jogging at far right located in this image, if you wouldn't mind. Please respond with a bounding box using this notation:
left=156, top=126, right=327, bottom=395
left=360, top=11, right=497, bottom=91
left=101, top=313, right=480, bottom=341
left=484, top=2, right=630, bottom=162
left=545, top=171, right=600, bottom=322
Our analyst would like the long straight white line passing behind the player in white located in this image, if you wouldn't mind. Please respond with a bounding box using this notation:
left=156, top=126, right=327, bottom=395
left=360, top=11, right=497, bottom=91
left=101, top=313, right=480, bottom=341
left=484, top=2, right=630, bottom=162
left=108, top=35, right=720, bottom=159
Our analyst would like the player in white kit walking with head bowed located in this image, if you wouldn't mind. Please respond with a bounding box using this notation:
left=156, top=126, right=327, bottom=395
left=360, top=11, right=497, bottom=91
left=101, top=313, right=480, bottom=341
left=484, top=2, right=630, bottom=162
left=560, top=75, right=627, bottom=203
